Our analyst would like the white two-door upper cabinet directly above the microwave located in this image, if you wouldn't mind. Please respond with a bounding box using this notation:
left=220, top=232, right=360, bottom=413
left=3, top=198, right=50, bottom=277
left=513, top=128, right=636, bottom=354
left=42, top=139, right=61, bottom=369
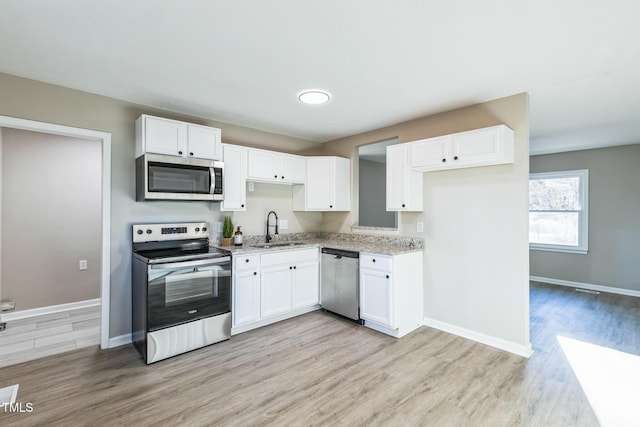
left=136, top=114, right=222, bottom=160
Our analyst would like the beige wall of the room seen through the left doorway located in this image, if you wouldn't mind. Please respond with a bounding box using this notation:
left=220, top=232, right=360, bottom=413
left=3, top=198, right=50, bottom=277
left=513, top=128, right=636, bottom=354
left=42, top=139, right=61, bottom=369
left=0, top=129, right=102, bottom=310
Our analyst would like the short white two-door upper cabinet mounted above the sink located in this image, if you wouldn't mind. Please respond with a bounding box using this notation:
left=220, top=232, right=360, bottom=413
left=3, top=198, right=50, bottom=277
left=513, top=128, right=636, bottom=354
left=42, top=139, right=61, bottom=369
left=247, top=148, right=306, bottom=184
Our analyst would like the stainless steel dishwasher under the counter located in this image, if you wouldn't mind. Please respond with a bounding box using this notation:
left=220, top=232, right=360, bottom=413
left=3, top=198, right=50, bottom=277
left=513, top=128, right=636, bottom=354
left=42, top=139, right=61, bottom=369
left=320, top=248, right=364, bottom=324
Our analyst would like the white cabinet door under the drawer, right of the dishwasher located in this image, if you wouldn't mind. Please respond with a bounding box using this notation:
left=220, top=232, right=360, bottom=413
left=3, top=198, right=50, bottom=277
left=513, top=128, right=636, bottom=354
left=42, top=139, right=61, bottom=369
left=360, top=268, right=394, bottom=328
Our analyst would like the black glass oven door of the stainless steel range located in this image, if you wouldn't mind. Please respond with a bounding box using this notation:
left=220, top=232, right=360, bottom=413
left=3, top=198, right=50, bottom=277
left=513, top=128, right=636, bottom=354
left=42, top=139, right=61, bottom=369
left=147, top=256, right=231, bottom=332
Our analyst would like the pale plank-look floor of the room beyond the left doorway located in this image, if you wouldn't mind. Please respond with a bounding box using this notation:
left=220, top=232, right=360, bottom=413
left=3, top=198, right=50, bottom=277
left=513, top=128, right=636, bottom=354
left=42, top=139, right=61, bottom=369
left=0, top=306, right=100, bottom=368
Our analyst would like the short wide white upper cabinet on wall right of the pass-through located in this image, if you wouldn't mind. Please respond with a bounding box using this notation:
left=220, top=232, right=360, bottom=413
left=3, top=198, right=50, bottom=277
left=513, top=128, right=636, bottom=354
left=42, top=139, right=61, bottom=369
left=408, top=125, right=514, bottom=172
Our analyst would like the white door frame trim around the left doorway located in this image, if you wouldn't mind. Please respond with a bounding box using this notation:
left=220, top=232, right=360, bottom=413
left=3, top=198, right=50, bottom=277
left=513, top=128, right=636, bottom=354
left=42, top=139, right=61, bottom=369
left=0, top=116, right=111, bottom=349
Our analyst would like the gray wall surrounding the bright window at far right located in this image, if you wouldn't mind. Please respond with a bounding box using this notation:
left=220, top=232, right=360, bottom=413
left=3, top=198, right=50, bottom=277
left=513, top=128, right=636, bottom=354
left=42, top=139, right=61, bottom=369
left=530, top=144, right=640, bottom=291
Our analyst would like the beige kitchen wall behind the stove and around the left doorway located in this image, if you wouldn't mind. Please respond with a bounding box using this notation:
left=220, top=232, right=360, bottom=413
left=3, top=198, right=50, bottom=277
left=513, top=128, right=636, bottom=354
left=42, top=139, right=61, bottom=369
left=0, top=74, right=318, bottom=337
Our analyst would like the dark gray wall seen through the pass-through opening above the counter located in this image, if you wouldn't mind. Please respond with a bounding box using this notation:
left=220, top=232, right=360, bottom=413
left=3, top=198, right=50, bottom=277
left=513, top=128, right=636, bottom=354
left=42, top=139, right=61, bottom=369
left=358, top=159, right=397, bottom=228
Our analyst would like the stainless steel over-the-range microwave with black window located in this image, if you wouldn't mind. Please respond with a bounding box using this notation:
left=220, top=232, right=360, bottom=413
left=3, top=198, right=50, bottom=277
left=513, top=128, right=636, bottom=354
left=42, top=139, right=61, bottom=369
left=136, top=153, right=224, bottom=201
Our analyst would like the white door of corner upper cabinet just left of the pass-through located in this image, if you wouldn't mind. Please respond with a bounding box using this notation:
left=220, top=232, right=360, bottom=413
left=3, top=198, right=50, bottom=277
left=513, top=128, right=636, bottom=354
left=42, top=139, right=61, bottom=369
left=305, top=157, right=335, bottom=211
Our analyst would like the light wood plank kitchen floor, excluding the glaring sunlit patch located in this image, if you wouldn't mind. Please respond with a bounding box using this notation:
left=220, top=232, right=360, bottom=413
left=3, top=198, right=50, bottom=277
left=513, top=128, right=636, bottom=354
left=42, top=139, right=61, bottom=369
left=0, top=284, right=640, bottom=427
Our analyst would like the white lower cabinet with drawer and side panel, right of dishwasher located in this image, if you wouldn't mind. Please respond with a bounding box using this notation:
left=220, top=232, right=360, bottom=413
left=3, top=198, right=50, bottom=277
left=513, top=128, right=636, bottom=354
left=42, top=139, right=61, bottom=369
left=360, top=251, right=424, bottom=338
